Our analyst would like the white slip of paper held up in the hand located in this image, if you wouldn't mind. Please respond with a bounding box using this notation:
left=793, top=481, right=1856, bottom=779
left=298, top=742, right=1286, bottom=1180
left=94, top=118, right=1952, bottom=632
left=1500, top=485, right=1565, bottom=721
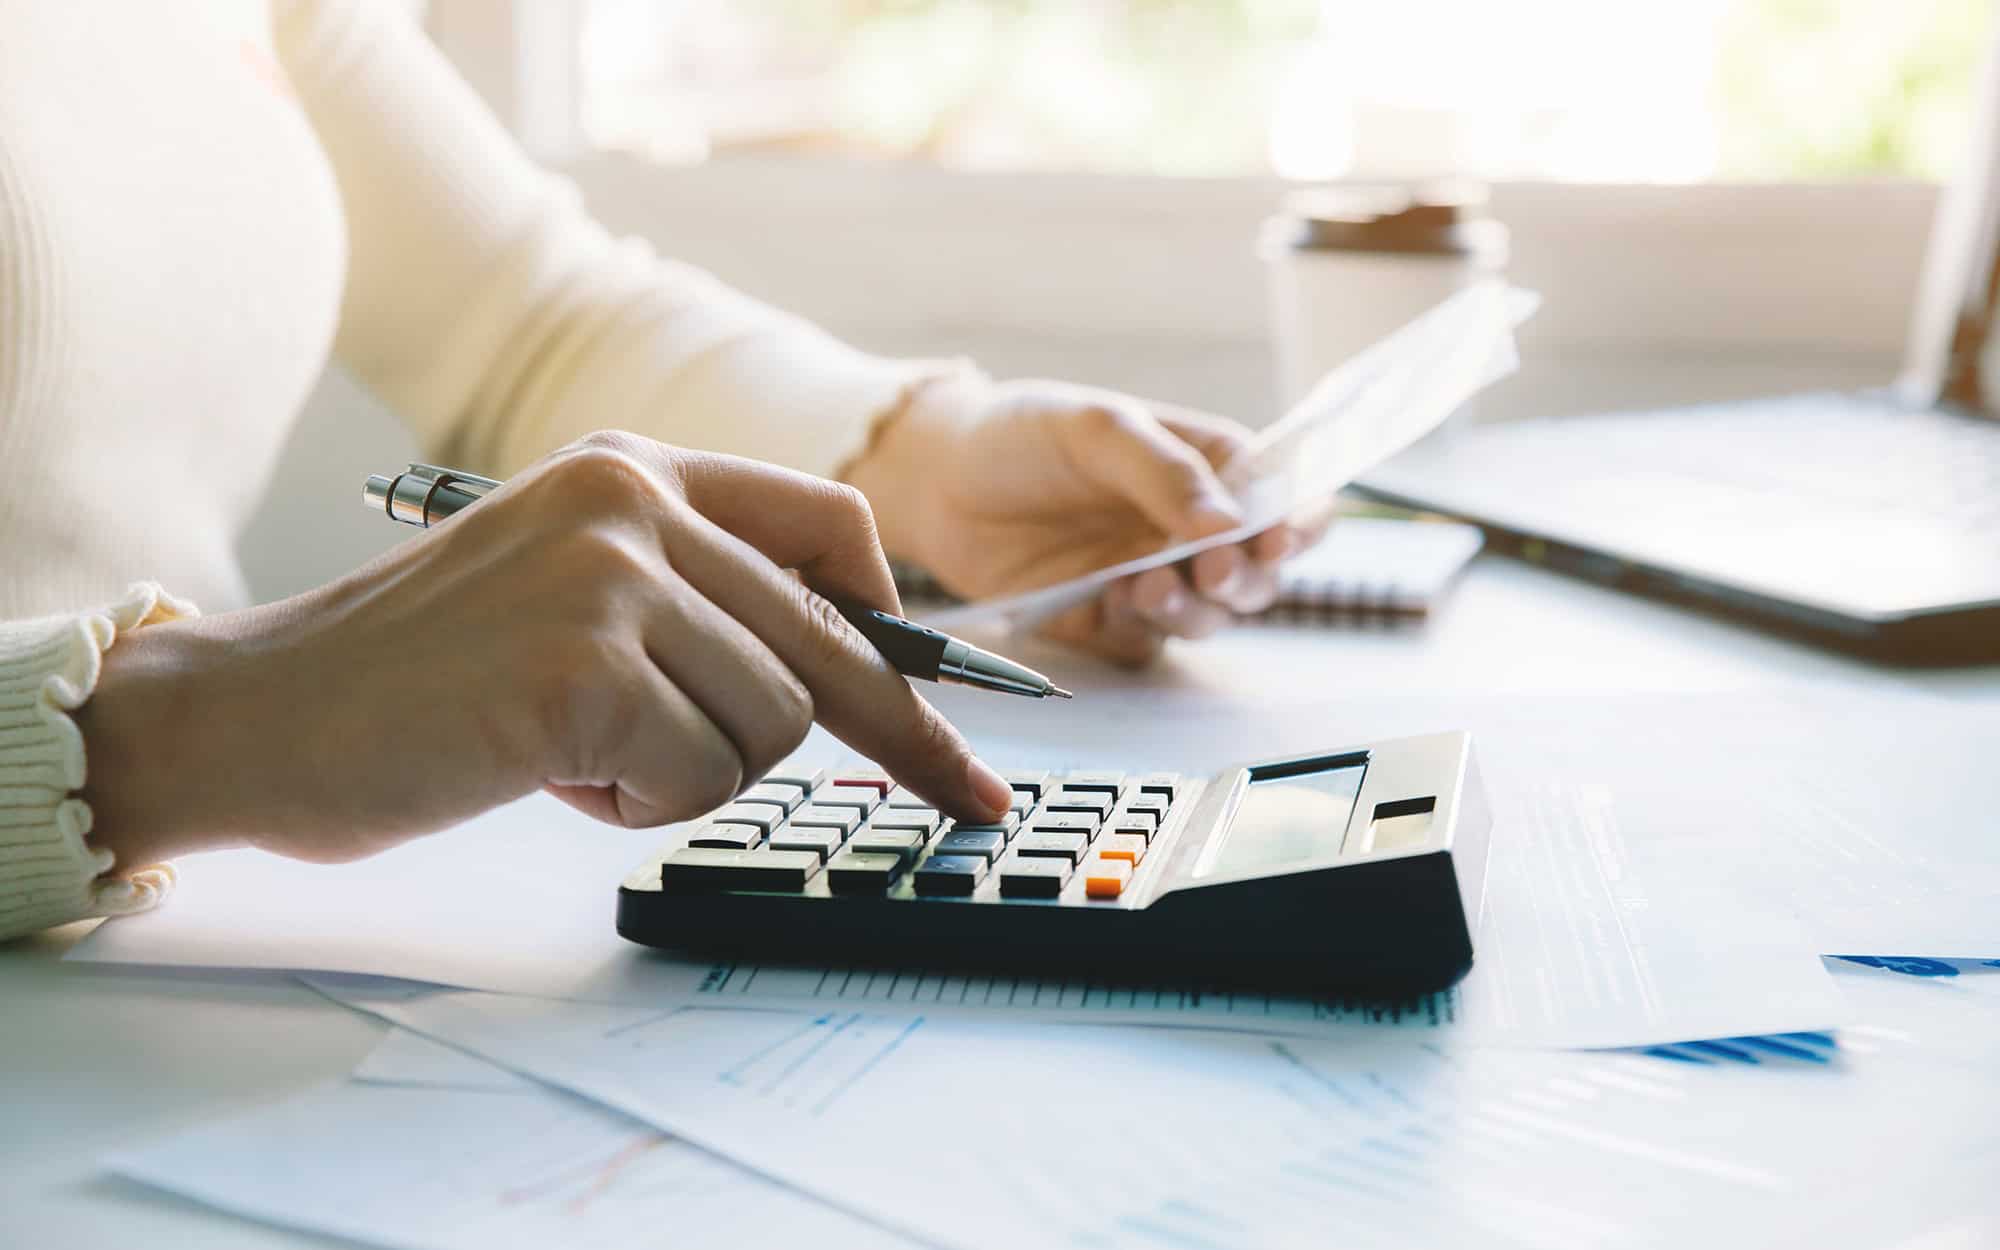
left=924, top=280, right=1540, bottom=630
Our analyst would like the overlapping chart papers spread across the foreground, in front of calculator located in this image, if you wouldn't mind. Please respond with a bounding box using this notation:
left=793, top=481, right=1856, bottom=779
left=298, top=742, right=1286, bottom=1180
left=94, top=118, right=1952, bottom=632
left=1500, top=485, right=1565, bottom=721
left=110, top=966, right=2000, bottom=1250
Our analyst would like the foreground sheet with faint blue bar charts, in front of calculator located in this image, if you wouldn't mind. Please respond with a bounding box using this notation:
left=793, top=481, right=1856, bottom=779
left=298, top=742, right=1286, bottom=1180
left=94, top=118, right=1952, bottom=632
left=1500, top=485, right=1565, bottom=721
left=292, top=978, right=2000, bottom=1248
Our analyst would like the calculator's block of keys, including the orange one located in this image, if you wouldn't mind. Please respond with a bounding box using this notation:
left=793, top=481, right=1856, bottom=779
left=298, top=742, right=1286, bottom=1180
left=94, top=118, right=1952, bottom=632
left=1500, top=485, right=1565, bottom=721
left=660, top=766, right=1184, bottom=902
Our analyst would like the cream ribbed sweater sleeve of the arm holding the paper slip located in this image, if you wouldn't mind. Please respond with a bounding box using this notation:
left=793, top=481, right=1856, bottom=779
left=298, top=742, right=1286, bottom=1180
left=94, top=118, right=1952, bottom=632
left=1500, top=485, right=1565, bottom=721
left=276, top=0, right=956, bottom=476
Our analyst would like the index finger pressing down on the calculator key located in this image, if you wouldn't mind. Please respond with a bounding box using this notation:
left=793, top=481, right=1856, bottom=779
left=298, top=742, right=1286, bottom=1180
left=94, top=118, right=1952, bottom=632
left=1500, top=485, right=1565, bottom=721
left=660, top=492, right=1014, bottom=820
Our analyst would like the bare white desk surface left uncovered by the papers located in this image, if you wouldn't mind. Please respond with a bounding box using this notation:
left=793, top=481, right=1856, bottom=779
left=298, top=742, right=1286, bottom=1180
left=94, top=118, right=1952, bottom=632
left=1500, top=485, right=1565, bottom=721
left=0, top=556, right=2000, bottom=1250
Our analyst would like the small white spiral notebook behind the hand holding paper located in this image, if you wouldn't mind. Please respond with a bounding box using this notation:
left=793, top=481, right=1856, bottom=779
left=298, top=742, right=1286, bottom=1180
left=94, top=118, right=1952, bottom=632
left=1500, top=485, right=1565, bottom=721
left=896, top=516, right=1484, bottom=624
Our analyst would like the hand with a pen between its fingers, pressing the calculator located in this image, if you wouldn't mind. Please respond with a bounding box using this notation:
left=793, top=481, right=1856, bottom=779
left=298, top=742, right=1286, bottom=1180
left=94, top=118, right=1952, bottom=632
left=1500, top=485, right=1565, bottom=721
left=78, top=434, right=1010, bottom=866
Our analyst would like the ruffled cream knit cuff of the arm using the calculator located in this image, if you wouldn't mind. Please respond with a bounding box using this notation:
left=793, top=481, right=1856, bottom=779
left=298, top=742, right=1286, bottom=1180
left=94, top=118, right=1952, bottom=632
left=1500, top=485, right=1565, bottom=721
left=0, top=582, right=194, bottom=940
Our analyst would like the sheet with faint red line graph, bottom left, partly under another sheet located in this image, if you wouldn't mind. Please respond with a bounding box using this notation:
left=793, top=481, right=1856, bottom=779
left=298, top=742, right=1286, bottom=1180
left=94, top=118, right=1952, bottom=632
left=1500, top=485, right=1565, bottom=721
left=106, top=1030, right=914, bottom=1250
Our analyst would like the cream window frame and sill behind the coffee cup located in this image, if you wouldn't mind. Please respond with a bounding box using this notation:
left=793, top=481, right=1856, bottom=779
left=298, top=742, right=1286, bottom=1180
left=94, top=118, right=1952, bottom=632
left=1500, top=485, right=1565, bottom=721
left=426, top=0, right=1938, bottom=372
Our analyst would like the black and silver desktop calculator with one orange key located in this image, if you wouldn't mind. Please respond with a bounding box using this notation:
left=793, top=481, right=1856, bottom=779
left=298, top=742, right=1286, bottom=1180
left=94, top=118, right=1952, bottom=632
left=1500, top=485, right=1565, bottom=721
left=618, top=732, right=1490, bottom=998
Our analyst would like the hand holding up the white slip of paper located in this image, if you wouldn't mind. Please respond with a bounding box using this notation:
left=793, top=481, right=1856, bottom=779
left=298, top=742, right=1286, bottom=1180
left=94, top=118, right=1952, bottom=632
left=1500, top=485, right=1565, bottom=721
left=846, top=376, right=1332, bottom=664
